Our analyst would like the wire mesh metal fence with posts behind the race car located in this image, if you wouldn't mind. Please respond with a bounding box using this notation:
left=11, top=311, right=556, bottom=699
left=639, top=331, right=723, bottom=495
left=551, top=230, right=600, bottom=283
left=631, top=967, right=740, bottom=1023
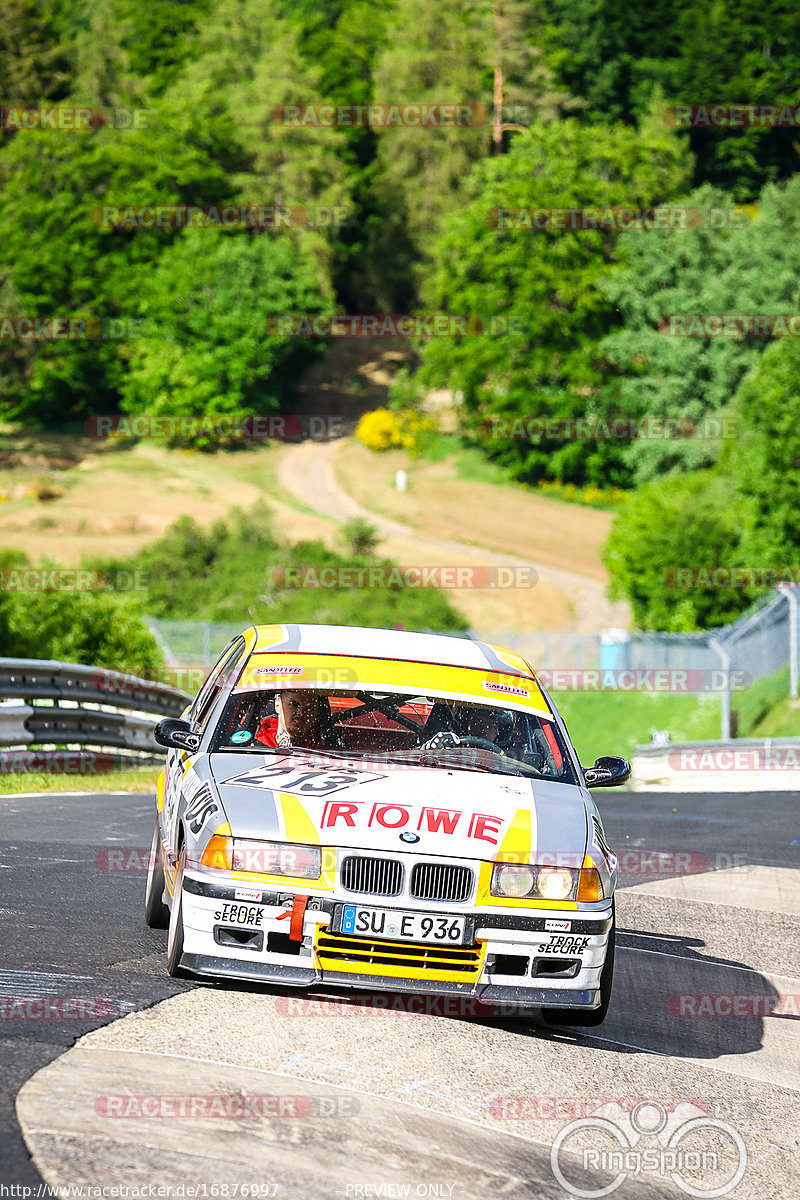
left=148, top=584, right=800, bottom=738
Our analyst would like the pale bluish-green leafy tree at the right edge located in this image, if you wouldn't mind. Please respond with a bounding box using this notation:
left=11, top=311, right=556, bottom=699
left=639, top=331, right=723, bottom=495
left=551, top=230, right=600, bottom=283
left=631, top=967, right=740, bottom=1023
left=597, top=176, right=800, bottom=480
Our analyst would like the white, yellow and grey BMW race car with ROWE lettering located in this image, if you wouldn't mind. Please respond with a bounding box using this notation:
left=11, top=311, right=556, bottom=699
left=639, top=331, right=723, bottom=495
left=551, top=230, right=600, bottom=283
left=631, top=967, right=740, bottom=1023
left=145, top=624, right=630, bottom=1025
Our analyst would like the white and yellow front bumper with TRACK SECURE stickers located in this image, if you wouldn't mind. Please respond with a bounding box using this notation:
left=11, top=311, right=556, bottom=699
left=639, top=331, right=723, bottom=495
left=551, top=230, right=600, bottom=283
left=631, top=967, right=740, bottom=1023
left=182, top=876, right=612, bottom=1009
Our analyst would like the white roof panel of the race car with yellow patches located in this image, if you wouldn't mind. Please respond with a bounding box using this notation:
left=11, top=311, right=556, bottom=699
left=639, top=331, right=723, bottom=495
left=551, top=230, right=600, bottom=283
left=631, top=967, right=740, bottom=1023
left=252, top=625, right=531, bottom=676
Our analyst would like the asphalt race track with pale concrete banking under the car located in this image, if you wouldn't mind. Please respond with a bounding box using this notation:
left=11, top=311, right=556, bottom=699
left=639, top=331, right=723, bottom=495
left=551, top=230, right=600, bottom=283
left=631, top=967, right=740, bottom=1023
left=0, top=792, right=800, bottom=1200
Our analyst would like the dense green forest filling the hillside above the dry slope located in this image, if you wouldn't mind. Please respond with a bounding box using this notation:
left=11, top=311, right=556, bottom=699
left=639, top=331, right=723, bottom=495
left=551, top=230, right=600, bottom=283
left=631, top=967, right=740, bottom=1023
left=0, top=0, right=800, bottom=630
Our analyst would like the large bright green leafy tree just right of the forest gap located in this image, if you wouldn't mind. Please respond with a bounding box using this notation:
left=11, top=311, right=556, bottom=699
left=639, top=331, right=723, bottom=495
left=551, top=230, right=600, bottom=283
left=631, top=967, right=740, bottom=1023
left=420, top=112, right=687, bottom=482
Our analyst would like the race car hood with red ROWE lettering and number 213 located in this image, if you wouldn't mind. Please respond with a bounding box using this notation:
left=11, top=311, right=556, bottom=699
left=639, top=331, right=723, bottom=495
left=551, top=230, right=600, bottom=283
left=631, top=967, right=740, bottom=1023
left=211, top=752, right=587, bottom=866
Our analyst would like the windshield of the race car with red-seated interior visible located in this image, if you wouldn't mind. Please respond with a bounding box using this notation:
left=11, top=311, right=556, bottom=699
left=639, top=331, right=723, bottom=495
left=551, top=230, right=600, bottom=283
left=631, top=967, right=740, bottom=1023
left=210, top=689, right=577, bottom=784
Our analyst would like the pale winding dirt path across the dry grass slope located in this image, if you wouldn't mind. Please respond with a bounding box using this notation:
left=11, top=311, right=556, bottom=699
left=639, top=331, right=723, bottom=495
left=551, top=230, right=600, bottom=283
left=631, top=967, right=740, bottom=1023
left=277, top=439, right=628, bottom=637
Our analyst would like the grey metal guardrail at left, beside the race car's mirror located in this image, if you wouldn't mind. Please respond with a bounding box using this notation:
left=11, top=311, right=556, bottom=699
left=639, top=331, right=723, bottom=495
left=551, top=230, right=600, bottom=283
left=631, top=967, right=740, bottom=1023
left=0, top=659, right=192, bottom=773
